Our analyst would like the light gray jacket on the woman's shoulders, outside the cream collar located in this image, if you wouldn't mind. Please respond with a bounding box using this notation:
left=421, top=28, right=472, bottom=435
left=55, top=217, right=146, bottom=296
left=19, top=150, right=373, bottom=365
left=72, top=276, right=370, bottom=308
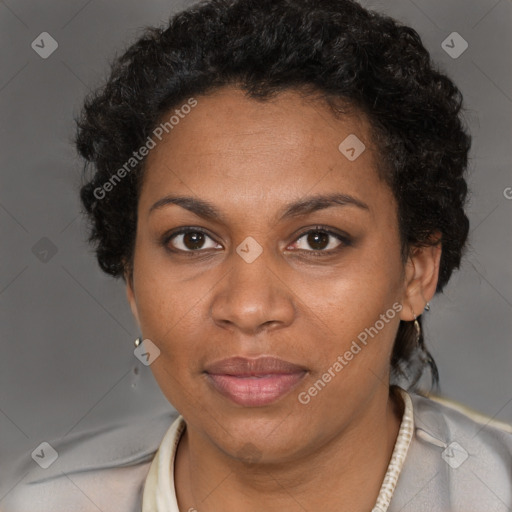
left=0, top=394, right=512, bottom=512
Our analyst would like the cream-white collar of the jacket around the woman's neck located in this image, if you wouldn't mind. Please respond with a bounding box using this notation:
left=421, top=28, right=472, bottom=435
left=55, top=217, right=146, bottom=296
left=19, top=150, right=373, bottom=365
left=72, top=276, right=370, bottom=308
left=142, top=388, right=414, bottom=512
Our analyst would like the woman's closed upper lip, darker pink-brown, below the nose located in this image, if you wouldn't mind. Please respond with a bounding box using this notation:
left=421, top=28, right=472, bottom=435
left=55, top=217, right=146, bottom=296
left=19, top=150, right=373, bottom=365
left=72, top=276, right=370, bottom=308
left=205, top=356, right=306, bottom=377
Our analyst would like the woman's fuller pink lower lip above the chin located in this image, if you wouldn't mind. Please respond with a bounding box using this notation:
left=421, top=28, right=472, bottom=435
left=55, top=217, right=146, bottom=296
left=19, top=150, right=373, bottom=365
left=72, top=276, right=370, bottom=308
left=207, top=372, right=306, bottom=407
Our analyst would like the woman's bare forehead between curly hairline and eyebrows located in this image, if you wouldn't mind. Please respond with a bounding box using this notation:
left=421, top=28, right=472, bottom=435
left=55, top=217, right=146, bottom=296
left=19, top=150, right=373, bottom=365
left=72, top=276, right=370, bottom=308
left=141, top=87, right=390, bottom=220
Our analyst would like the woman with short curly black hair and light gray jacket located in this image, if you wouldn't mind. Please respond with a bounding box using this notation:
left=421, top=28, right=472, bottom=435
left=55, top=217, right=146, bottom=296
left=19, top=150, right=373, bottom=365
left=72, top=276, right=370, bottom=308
left=7, top=0, right=512, bottom=512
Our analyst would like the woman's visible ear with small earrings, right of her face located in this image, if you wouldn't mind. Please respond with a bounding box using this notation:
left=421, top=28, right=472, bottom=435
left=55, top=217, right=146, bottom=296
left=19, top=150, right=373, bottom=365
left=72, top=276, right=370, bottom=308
left=400, top=234, right=442, bottom=321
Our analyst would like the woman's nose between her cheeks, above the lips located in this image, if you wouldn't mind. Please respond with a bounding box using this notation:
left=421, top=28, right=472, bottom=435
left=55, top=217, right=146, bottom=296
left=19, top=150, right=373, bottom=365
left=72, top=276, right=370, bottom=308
left=211, top=244, right=296, bottom=335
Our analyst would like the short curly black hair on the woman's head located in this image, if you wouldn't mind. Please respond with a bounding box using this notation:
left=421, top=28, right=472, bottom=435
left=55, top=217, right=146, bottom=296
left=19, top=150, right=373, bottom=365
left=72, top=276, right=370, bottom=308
left=76, top=0, right=471, bottom=388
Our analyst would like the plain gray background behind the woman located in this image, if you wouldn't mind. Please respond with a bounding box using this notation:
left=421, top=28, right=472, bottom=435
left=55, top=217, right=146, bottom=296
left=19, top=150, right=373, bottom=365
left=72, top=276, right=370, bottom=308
left=0, top=0, right=512, bottom=500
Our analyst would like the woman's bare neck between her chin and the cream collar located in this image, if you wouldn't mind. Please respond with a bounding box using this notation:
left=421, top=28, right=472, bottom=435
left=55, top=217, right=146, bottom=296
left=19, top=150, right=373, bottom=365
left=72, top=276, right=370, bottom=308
left=175, top=393, right=403, bottom=512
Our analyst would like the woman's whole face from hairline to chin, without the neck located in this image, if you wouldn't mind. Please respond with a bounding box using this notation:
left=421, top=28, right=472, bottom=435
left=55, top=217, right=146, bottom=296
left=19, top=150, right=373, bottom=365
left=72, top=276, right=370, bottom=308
left=128, top=87, right=433, bottom=461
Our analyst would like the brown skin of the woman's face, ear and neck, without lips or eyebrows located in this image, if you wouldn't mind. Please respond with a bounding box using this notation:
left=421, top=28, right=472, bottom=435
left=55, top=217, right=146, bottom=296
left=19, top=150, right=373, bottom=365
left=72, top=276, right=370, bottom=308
left=127, top=87, right=441, bottom=512
